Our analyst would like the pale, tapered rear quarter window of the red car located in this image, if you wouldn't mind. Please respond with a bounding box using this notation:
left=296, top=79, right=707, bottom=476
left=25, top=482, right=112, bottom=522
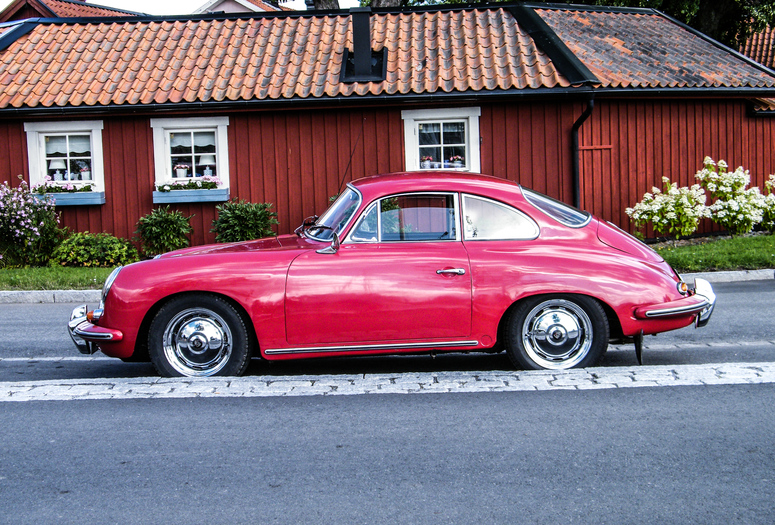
left=463, top=195, right=539, bottom=241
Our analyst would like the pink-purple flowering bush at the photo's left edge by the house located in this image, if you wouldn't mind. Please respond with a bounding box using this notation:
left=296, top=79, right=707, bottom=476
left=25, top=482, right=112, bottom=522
left=0, top=177, right=62, bottom=267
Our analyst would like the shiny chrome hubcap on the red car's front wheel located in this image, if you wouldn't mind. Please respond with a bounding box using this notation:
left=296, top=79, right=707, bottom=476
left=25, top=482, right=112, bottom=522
left=164, top=308, right=232, bottom=377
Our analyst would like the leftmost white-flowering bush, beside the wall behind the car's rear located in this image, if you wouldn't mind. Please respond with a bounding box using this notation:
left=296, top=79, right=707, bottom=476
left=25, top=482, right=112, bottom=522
left=625, top=177, right=709, bottom=238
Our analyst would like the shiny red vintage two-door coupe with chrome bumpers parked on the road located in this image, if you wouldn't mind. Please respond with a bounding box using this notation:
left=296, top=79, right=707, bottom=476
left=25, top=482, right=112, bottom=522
left=69, top=172, right=716, bottom=376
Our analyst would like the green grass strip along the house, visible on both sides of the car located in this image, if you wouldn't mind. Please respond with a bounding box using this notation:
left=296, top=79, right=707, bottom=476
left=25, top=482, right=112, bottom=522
left=0, top=235, right=775, bottom=290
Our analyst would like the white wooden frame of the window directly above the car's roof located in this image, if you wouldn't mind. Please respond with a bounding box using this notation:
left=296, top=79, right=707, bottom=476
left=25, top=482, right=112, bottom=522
left=401, top=107, right=482, bottom=172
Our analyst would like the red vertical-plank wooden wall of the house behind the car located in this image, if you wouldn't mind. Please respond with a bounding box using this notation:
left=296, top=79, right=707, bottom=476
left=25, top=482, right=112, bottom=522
left=0, top=98, right=775, bottom=244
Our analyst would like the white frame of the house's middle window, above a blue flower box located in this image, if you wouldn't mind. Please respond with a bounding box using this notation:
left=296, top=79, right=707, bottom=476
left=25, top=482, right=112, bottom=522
left=151, top=117, right=229, bottom=191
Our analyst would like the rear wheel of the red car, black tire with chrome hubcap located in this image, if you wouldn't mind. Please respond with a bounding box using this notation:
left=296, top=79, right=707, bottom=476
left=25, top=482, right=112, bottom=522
left=506, top=295, right=609, bottom=370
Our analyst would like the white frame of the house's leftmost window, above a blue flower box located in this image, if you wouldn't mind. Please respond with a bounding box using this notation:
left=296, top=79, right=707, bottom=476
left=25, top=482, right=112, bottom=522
left=24, top=120, right=105, bottom=192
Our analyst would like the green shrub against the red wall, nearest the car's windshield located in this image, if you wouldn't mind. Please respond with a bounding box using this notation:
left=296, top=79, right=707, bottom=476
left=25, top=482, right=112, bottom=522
left=210, top=200, right=280, bottom=242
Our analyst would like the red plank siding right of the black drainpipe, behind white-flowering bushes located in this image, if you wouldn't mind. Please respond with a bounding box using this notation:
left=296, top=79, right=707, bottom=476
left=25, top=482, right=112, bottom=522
left=580, top=100, right=775, bottom=231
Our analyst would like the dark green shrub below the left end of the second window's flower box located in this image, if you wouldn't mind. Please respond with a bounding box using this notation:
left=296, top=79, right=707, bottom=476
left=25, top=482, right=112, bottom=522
left=135, top=206, right=194, bottom=257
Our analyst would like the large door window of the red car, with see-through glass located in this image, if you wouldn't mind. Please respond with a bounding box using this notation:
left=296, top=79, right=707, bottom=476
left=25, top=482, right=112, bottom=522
left=379, top=194, right=457, bottom=242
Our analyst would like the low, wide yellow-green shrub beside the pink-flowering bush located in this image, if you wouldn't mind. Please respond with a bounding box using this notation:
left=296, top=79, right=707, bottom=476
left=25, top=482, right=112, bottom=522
left=51, top=232, right=139, bottom=267
